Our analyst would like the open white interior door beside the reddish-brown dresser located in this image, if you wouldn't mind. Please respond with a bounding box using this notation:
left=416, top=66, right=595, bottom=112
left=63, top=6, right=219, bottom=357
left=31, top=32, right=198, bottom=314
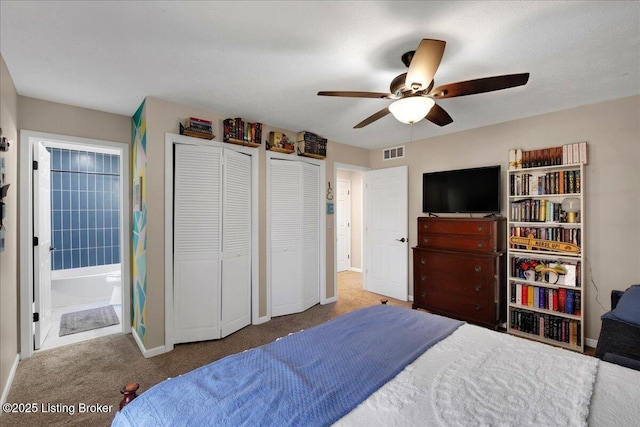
left=363, top=166, right=409, bottom=301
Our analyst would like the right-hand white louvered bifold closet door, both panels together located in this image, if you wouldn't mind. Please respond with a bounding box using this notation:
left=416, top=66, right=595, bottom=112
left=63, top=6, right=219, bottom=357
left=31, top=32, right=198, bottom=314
left=268, top=159, right=320, bottom=317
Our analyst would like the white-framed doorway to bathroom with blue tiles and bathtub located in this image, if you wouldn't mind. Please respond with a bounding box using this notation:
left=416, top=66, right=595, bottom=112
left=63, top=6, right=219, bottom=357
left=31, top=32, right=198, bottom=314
left=20, top=131, right=131, bottom=359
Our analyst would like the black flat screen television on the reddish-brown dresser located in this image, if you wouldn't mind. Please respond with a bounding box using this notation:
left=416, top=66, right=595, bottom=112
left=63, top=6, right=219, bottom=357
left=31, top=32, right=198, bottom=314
left=422, top=165, right=501, bottom=214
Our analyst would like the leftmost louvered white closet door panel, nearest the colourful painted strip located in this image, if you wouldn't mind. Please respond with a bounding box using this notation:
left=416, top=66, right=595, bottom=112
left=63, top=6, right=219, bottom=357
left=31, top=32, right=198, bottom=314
left=173, top=144, right=222, bottom=344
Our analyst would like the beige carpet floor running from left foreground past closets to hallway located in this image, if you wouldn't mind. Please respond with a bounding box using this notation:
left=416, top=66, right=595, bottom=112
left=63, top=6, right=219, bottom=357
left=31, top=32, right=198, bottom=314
left=0, top=272, right=411, bottom=427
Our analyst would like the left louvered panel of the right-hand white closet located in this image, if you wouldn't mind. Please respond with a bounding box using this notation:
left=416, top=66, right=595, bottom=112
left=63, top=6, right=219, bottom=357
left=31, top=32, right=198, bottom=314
left=269, top=159, right=303, bottom=316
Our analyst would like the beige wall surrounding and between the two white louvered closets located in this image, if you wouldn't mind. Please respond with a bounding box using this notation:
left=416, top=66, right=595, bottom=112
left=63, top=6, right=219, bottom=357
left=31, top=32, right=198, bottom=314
left=141, top=97, right=368, bottom=348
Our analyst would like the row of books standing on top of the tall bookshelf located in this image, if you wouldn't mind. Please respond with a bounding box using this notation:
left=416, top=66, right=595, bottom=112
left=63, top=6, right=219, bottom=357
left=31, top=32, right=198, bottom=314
left=509, top=141, right=588, bottom=170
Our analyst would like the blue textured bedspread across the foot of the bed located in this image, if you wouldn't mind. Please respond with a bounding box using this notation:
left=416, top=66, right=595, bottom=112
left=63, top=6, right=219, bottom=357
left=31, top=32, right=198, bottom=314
left=112, top=305, right=463, bottom=426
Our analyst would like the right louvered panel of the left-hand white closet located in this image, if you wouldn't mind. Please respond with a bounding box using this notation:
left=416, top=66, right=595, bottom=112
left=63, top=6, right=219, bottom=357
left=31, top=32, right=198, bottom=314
left=221, top=150, right=252, bottom=337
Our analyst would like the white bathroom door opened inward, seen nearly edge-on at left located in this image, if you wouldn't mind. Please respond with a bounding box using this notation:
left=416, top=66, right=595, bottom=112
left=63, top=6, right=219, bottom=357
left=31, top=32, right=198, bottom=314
left=33, top=142, right=51, bottom=350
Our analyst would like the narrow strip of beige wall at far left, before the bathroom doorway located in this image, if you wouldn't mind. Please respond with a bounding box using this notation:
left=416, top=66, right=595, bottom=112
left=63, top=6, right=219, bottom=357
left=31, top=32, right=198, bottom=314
left=0, top=55, right=19, bottom=404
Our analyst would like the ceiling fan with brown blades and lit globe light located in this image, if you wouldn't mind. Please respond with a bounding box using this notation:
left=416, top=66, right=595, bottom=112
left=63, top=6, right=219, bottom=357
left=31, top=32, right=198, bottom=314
left=318, top=39, right=529, bottom=129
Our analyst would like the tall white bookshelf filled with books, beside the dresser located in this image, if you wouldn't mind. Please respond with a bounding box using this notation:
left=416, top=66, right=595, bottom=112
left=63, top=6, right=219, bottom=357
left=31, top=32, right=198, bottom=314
left=507, top=159, right=586, bottom=352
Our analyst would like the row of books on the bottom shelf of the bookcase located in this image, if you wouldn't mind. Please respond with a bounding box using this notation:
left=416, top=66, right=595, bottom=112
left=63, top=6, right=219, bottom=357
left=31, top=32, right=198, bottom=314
left=509, top=310, right=582, bottom=346
